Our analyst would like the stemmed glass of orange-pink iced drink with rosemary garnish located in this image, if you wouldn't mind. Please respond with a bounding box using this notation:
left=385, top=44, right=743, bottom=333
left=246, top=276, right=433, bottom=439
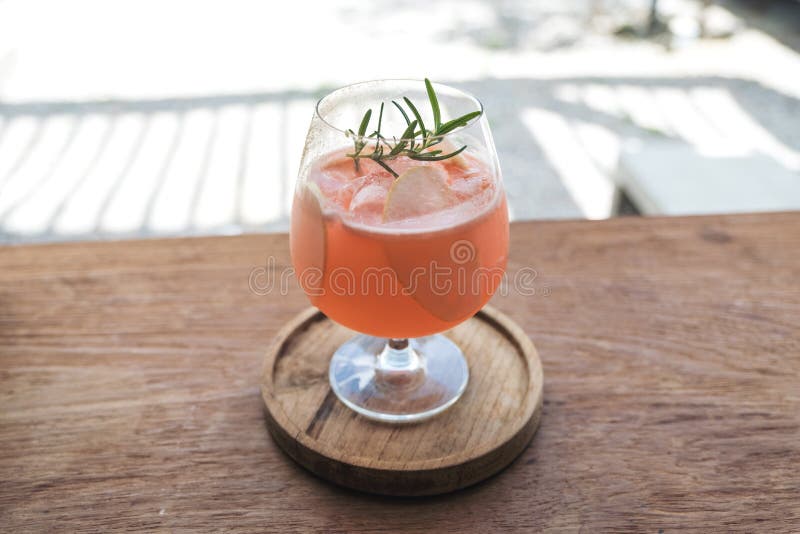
left=290, top=80, right=508, bottom=422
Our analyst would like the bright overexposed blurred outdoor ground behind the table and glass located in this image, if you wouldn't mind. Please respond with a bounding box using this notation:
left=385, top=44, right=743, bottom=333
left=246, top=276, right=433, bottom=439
left=0, top=0, right=800, bottom=243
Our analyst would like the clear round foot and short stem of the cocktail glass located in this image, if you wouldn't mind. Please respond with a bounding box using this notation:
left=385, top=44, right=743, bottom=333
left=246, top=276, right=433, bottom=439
left=330, top=334, right=469, bottom=423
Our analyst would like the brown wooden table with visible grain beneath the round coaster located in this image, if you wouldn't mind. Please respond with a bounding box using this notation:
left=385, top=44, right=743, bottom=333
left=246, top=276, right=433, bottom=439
left=0, top=213, right=800, bottom=532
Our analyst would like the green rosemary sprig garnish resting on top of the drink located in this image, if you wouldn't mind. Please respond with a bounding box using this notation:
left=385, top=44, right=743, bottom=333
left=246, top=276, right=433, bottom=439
left=347, top=78, right=481, bottom=178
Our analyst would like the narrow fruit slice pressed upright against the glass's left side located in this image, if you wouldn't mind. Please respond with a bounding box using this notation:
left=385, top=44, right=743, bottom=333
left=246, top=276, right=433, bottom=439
left=290, top=182, right=326, bottom=302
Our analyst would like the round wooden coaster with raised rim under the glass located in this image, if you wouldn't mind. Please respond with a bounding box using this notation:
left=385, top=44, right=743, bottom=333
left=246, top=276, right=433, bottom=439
left=261, top=306, right=542, bottom=496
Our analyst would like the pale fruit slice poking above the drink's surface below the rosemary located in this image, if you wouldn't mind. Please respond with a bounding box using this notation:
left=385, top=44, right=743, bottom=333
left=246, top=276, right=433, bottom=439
left=383, top=166, right=458, bottom=222
